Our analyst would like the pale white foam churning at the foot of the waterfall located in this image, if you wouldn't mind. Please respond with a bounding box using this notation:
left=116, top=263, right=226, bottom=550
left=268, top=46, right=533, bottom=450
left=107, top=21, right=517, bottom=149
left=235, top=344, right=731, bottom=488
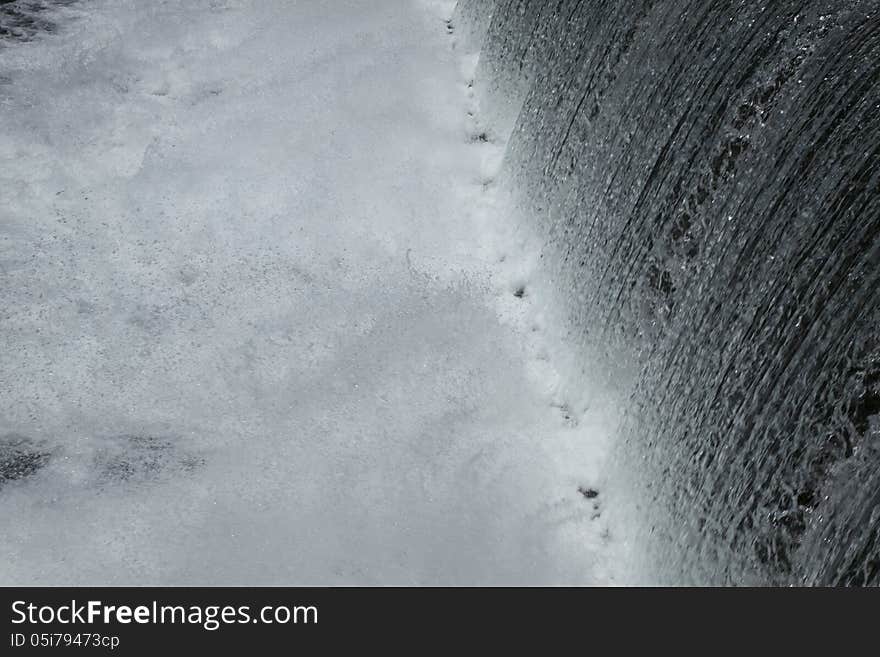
left=0, top=0, right=617, bottom=584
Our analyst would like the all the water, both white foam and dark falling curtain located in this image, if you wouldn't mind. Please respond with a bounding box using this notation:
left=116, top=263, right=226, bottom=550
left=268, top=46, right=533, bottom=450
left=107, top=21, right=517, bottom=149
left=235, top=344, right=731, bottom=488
left=0, top=0, right=880, bottom=585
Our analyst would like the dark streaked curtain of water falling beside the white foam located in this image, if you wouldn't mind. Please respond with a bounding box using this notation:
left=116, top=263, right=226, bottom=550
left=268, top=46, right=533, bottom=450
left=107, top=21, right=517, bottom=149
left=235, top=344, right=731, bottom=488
left=453, top=0, right=880, bottom=585
